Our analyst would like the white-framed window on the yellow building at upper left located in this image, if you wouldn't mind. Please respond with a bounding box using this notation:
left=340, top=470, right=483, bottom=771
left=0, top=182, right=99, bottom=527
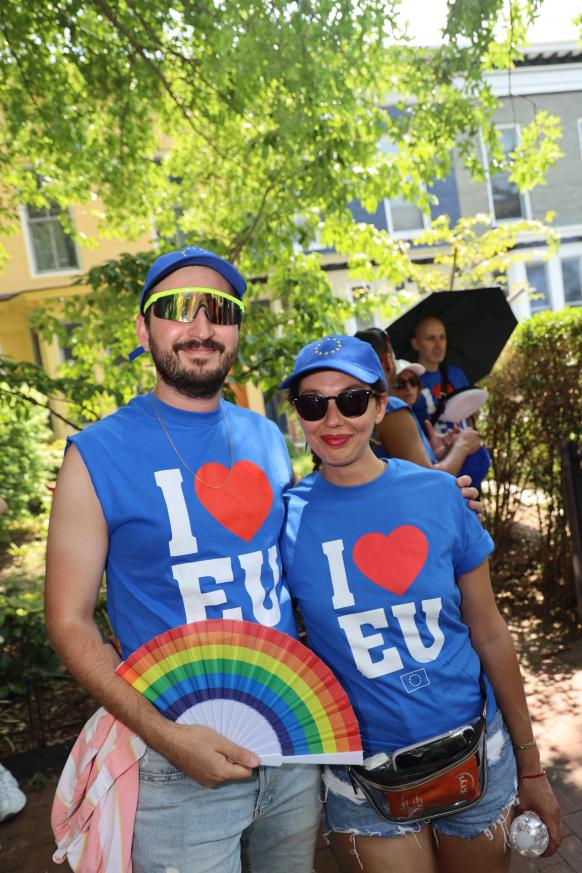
left=25, top=206, right=79, bottom=273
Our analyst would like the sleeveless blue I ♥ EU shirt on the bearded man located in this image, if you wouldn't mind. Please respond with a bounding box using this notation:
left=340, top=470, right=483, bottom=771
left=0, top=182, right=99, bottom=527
left=71, top=394, right=296, bottom=657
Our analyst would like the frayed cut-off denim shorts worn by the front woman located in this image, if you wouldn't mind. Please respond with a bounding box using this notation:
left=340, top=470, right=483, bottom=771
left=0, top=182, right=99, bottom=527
left=323, top=710, right=517, bottom=839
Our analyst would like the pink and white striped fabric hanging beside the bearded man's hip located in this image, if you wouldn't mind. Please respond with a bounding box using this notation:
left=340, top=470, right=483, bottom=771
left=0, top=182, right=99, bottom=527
left=51, top=708, right=146, bottom=873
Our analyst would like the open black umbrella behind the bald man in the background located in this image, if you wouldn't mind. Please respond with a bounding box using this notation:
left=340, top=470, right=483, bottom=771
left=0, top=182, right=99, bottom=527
left=386, top=285, right=517, bottom=383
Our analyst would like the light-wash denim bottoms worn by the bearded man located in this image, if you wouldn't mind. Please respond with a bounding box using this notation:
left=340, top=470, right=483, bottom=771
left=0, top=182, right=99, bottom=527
left=132, top=749, right=322, bottom=873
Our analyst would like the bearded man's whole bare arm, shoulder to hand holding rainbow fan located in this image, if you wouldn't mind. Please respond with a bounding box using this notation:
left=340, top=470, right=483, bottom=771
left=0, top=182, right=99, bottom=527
left=45, top=445, right=259, bottom=787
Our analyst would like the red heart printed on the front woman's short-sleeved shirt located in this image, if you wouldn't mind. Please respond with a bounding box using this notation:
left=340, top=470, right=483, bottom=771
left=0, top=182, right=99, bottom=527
left=353, top=524, right=428, bottom=595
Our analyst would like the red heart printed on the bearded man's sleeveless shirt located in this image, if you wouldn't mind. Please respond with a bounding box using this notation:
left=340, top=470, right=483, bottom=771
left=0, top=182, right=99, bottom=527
left=194, top=461, right=273, bottom=543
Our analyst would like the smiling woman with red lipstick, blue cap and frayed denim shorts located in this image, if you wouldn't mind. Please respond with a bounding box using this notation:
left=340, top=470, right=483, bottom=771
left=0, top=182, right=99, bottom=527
left=282, top=336, right=560, bottom=873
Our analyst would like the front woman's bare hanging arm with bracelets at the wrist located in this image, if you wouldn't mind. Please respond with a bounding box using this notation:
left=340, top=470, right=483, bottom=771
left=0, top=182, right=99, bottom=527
left=459, top=561, right=562, bottom=857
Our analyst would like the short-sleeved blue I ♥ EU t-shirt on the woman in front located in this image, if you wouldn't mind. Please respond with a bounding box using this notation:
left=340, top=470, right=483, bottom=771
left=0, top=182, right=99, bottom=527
left=283, top=460, right=496, bottom=755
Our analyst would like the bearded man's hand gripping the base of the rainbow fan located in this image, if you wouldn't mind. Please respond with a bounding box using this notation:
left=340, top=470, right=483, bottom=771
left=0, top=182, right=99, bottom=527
left=164, top=723, right=260, bottom=788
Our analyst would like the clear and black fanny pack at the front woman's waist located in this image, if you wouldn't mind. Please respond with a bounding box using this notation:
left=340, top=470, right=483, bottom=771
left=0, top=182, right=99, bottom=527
left=347, top=704, right=487, bottom=824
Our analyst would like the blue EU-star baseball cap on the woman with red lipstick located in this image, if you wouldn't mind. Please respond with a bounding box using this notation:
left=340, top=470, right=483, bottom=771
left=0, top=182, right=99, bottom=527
left=280, top=334, right=386, bottom=388
